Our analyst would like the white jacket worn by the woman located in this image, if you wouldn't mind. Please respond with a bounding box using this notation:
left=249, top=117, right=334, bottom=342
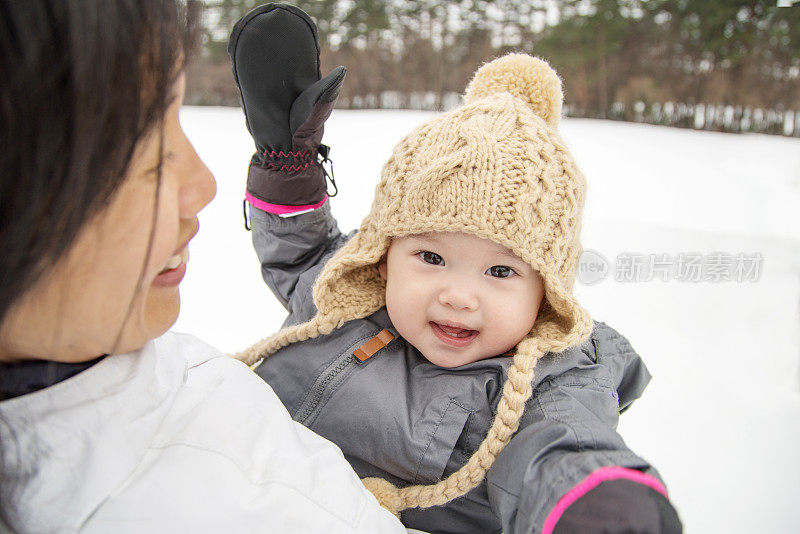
left=0, top=333, right=406, bottom=534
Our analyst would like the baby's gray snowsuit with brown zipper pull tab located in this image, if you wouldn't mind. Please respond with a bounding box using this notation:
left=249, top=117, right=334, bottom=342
left=250, top=203, right=658, bottom=534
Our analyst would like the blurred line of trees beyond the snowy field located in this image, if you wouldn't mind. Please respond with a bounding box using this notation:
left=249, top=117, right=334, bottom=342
left=187, top=0, right=800, bottom=136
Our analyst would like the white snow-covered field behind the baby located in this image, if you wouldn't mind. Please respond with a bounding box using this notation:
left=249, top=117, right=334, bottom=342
left=175, top=107, right=800, bottom=534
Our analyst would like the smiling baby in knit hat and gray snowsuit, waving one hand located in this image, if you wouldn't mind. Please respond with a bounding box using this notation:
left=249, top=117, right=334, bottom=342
left=228, top=4, right=681, bottom=534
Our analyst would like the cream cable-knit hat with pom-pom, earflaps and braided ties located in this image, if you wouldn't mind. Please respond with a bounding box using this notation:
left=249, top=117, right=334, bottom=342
left=236, top=54, right=592, bottom=513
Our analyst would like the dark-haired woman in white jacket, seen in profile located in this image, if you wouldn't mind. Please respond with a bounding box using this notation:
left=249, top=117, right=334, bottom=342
left=0, top=0, right=405, bottom=532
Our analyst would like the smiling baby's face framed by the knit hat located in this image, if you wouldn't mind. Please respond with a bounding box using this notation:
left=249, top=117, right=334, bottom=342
left=378, top=232, right=544, bottom=367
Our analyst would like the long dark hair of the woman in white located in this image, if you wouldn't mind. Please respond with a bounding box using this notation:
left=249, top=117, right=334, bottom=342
left=0, top=0, right=198, bottom=324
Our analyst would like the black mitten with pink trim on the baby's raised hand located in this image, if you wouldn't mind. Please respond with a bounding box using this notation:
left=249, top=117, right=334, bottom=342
left=228, top=4, right=346, bottom=214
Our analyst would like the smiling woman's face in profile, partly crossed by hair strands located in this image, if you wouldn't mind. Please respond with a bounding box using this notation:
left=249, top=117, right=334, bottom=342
left=0, top=76, right=216, bottom=362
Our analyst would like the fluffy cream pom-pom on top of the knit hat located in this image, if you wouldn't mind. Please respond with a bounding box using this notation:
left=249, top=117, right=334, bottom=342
left=464, top=54, right=564, bottom=127
